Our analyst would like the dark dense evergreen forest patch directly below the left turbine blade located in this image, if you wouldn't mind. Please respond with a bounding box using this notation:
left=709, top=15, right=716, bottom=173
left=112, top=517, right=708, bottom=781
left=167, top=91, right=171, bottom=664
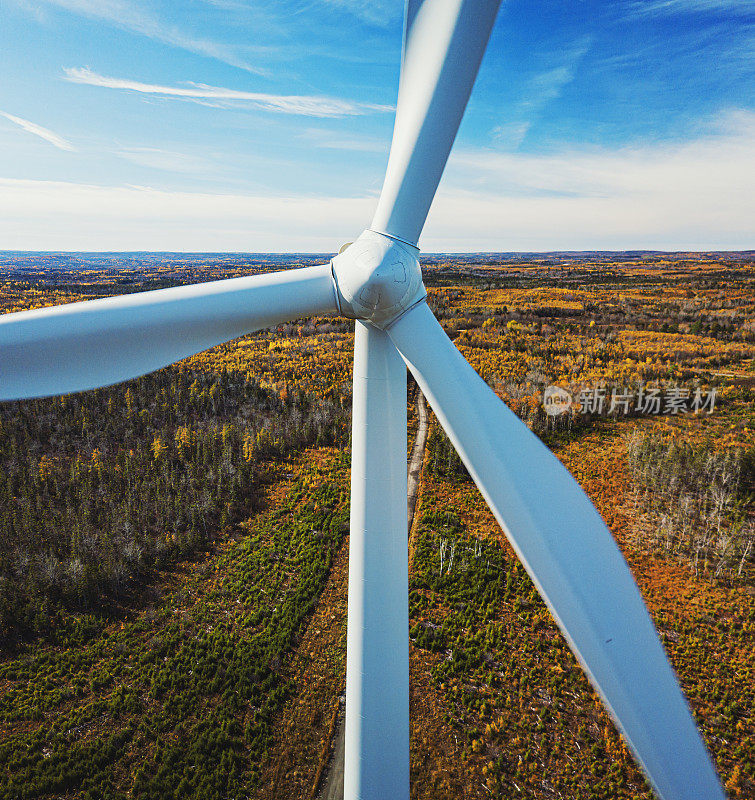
left=0, top=367, right=349, bottom=644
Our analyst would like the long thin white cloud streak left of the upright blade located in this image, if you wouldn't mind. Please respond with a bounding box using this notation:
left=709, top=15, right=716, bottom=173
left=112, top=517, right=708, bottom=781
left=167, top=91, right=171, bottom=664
left=64, top=67, right=393, bottom=117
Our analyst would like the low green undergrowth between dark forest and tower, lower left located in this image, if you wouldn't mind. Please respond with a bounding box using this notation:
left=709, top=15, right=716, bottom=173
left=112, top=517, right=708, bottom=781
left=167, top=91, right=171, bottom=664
left=0, top=456, right=348, bottom=800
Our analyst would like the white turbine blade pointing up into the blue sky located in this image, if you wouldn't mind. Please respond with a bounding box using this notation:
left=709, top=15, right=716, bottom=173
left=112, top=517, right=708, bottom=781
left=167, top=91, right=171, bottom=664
left=371, top=0, right=500, bottom=244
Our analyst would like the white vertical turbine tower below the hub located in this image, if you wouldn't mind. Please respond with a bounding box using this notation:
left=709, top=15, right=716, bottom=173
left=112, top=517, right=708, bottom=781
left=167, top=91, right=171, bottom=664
left=344, top=321, right=409, bottom=800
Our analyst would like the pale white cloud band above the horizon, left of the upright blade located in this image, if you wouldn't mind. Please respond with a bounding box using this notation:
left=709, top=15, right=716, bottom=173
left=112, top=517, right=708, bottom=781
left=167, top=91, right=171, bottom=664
left=0, top=178, right=375, bottom=252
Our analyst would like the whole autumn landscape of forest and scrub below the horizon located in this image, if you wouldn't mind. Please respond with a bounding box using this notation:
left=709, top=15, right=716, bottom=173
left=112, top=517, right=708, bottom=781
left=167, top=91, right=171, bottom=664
left=0, top=248, right=755, bottom=800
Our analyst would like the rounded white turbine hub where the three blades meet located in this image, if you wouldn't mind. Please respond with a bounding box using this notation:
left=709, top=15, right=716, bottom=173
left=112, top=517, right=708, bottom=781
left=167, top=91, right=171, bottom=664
left=331, top=230, right=427, bottom=328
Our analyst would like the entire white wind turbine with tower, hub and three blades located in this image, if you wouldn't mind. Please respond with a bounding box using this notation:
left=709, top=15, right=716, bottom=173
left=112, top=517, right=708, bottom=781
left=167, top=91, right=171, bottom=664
left=0, top=0, right=724, bottom=800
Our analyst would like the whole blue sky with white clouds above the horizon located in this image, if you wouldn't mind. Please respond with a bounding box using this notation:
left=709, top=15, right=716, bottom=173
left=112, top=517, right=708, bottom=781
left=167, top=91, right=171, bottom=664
left=0, top=0, right=755, bottom=252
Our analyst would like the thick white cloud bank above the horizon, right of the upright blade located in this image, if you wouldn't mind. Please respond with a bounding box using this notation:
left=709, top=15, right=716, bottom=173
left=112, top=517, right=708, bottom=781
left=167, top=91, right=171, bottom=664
left=426, top=110, right=755, bottom=250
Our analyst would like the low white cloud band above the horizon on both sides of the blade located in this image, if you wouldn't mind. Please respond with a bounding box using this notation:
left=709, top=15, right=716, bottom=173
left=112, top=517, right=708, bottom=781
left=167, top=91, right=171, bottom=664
left=0, top=110, right=755, bottom=252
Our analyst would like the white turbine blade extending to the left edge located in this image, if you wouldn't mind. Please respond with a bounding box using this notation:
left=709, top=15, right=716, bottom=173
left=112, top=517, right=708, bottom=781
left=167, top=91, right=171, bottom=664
left=0, top=264, right=337, bottom=400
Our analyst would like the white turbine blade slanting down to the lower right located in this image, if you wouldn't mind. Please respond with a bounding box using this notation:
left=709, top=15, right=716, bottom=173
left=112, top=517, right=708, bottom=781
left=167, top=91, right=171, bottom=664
left=388, top=303, right=724, bottom=800
